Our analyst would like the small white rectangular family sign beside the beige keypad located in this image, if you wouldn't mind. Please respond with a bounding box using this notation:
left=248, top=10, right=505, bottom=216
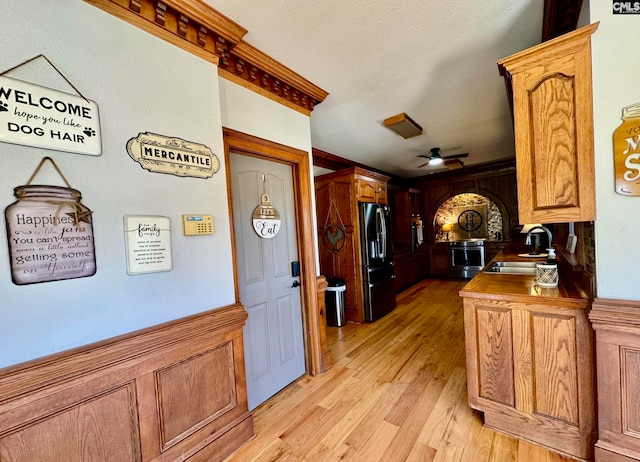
left=124, top=215, right=173, bottom=276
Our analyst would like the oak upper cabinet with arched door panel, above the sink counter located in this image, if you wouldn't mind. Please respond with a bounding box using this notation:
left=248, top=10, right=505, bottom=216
left=498, top=23, right=598, bottom=224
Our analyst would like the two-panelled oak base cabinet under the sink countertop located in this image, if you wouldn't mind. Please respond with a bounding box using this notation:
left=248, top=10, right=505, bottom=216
left=464, top=297, right=595, bottom=460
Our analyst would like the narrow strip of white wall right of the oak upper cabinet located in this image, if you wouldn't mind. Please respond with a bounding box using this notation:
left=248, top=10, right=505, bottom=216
left=589, top=1, right=640, bottom=300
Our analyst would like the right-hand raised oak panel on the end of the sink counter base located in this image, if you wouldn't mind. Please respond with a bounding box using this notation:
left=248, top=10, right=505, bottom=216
left=533, top=313, right=579, bottom=425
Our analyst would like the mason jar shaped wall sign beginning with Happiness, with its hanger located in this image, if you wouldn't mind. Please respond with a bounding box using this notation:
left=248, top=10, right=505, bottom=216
left=5, top=157, right=96, bottom=285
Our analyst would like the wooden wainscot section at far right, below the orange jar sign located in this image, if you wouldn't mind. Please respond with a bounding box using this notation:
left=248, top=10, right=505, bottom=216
left=589, top=299, right=640, bottom=462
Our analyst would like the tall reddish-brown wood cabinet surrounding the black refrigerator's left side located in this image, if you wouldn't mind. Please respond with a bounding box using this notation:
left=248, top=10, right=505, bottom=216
left=315, top=167, right=389, bottom=322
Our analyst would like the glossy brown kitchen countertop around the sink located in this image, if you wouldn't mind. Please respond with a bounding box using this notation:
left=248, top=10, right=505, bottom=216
left=459, top=245, right=590, bottom=309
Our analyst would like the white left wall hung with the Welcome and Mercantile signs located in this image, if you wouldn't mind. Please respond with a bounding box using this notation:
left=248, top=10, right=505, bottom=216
left=0, top=0, right=238, bottom=367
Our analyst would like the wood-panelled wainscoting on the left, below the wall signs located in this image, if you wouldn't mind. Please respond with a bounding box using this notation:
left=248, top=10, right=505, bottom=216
left=0, top=304, right=254, bottom=462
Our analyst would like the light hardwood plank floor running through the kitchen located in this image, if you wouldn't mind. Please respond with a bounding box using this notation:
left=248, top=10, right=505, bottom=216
left=228, top=279, right=570, bottom=462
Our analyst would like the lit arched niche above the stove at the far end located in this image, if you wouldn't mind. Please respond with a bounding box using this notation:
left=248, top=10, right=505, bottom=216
left=429, top=190, right=510, bottom=242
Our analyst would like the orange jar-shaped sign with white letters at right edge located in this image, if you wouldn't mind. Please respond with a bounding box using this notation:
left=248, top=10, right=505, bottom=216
left=613, top=103, right=640, bottom=196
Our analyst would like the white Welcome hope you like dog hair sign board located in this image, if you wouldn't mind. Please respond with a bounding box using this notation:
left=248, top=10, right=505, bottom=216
left=0, top=76, right=102, bottom=156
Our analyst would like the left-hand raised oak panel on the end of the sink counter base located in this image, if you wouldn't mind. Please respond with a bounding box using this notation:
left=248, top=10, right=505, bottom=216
left=476, top=307, right=515, bottom=407
